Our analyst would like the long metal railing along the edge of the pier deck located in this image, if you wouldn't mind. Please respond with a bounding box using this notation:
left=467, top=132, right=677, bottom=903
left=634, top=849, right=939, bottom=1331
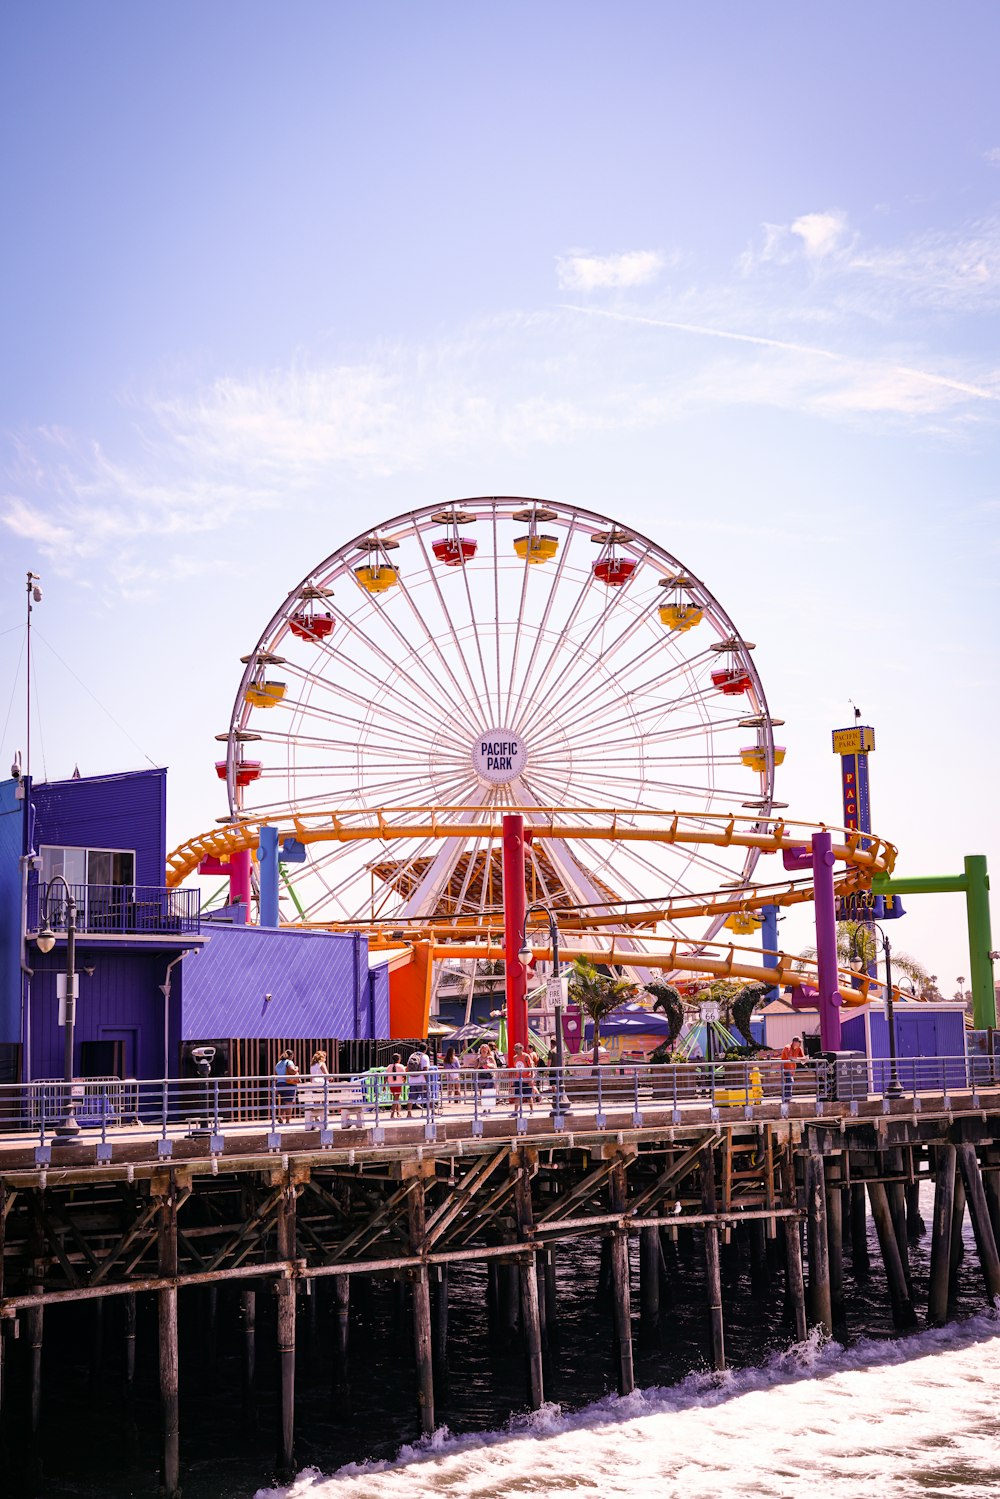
left=0, top=1055, right=1000, bottom=1165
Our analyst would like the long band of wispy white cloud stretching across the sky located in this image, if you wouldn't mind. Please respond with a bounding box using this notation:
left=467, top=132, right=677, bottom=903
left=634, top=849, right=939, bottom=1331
left=7, top=210, right=1000, bottom=592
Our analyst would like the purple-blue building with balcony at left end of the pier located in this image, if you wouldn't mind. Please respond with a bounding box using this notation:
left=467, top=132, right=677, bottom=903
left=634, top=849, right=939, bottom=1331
left=0, top=769, right=390, bottom=1081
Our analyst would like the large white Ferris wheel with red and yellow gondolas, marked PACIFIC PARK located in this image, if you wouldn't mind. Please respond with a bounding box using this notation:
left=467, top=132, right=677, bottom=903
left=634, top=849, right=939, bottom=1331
left=216, top=496, right=784, bottom=940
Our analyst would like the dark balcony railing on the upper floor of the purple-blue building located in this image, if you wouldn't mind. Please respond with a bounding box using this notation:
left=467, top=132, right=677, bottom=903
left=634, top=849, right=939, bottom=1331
left=28, top=880, right=201, bottom=937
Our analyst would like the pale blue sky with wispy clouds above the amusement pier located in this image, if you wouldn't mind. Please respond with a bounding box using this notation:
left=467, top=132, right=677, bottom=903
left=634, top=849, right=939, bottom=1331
left=0, top=0, right=1000, bottom=988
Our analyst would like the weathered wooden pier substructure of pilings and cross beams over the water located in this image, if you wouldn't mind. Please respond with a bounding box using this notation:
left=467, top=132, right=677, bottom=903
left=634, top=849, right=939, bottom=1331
left=0, top=1088, right=1000, bottom=1499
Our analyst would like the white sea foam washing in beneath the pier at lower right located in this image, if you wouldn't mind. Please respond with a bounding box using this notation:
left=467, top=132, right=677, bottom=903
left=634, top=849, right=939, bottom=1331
left=258, top=1316, right=1000, bottom=1499
